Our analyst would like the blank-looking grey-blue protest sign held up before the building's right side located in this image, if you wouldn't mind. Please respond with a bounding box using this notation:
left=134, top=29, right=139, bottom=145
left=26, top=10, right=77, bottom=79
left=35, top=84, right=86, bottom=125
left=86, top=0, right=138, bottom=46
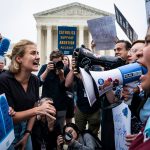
left=87, top=16, right=116, bottom=50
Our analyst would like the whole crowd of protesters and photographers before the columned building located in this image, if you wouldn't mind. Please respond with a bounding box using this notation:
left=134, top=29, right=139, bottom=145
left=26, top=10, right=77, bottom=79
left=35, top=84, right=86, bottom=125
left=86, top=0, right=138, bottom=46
left=0, top=30, right=150, bottom=150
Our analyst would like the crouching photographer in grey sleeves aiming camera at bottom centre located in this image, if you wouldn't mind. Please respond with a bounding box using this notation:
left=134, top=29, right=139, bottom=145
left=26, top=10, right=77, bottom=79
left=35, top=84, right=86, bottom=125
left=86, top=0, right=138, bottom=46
left=57, top=123, right=101, bottom=150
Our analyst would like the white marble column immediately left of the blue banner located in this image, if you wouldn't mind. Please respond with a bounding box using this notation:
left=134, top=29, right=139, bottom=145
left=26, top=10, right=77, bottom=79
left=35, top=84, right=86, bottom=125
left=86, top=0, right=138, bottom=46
left=46, top=26, right=53, bottom=61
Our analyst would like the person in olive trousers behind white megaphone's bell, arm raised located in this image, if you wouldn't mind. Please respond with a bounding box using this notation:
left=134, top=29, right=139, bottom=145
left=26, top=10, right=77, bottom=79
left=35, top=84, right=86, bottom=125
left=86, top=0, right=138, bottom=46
left=65, top=52, right=100, bottom=135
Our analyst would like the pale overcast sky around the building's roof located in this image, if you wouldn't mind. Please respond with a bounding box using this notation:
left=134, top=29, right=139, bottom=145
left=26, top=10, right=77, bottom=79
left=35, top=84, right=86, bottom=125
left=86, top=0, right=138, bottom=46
left=0, top=0, right=147, bottom=43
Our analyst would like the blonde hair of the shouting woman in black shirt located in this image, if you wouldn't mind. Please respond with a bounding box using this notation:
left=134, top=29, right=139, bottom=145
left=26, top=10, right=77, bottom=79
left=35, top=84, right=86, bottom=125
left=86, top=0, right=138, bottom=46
left=7, top=40, right=36, bottom=74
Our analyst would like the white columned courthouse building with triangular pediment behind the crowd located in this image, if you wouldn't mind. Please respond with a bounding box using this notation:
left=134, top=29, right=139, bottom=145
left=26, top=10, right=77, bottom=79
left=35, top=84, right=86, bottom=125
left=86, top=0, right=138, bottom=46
left=34, top=2, right=112, bottom=64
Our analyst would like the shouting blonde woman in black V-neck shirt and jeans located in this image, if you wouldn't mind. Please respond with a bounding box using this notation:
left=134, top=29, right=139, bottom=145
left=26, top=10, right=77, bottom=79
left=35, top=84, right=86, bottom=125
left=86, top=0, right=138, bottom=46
left=0, top=40, right=56, bottom=150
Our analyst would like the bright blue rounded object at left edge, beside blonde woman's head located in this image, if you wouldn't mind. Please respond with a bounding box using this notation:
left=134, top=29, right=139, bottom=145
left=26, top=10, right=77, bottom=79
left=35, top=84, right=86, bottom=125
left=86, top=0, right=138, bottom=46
left=0, top=38, right=10, bottom=56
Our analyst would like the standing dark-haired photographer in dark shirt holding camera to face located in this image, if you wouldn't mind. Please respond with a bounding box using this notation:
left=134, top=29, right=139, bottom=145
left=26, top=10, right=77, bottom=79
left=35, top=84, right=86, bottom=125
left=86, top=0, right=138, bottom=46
left=38, top=50, right=67, bottom=130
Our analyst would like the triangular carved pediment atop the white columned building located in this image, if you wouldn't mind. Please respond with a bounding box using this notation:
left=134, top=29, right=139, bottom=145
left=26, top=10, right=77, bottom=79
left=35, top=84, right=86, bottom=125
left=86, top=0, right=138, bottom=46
left=34, top=2, right=112, bottom=18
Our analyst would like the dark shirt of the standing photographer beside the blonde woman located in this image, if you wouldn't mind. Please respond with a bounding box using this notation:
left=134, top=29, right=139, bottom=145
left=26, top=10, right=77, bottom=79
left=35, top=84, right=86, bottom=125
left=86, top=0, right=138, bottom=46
left=38, top=64, right=67, bottom=111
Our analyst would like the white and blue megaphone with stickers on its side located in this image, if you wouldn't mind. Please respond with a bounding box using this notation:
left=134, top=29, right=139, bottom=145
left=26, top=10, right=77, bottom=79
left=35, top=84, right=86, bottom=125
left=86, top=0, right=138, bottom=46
left=80, top=63, right=147, bottom=106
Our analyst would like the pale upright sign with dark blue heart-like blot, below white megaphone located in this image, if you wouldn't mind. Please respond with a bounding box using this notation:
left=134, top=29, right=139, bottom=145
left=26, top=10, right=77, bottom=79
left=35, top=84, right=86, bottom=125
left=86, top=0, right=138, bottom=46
left=112, top=102, right=131, bottom=150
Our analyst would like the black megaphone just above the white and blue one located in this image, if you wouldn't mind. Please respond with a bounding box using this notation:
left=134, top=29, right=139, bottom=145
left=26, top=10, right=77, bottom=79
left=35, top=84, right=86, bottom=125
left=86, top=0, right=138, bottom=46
left=73, top=47, right=125, bottom=70
